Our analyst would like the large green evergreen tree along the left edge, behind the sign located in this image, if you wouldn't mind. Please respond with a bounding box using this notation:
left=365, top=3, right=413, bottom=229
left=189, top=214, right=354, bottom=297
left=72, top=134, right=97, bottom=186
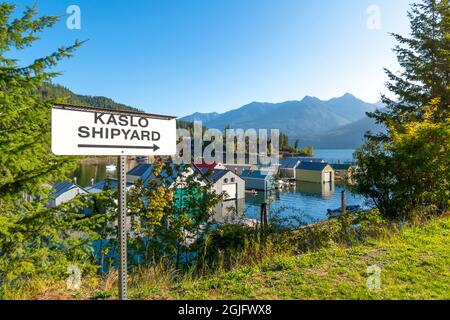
left=0, top=2, right=97, bottom=298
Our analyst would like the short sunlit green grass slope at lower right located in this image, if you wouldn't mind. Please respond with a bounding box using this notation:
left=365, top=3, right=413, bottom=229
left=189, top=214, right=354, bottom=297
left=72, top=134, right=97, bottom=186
left=134, top=217, right=450, bottom=299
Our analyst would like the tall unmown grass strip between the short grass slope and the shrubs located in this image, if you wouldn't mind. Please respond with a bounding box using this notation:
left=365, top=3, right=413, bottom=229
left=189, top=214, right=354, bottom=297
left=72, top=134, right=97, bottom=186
left=8, top=210, right=444, bottom=299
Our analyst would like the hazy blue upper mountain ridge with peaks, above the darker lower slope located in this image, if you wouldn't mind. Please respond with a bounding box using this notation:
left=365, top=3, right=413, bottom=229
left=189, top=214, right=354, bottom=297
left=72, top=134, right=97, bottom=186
left=180, top=93, right=377, bottom=136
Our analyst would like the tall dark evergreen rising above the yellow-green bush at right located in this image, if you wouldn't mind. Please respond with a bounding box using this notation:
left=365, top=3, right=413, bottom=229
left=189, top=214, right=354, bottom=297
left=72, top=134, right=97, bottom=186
left=370, top=0, right=450, bottom=125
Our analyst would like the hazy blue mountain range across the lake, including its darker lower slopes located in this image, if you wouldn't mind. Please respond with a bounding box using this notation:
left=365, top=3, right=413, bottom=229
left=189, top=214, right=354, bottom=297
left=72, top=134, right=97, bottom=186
left=180, top=93, right=383, bottom=149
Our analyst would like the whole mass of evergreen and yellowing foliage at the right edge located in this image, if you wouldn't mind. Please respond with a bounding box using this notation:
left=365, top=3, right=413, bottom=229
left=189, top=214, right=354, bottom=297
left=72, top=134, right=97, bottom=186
left=353, top=0, right=450, bottom=219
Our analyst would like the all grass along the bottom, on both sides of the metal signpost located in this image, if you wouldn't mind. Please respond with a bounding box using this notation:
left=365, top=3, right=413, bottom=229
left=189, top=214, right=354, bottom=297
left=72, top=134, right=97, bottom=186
left=12, top=216, right=450, bottom=300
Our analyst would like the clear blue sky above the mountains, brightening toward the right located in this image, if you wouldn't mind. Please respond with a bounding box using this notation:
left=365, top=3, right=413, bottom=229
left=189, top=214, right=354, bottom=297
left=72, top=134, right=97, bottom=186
left=10, top=0, right=411, bottom=116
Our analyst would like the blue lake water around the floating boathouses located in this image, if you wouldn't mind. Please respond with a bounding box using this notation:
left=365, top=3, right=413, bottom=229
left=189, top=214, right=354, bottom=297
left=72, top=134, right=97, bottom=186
left=74, top=150, right=364, bottom=222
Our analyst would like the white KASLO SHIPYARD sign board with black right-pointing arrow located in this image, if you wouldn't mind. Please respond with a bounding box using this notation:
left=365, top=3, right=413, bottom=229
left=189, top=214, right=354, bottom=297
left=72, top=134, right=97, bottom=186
left=52, top=105, right=176, bottom=156
